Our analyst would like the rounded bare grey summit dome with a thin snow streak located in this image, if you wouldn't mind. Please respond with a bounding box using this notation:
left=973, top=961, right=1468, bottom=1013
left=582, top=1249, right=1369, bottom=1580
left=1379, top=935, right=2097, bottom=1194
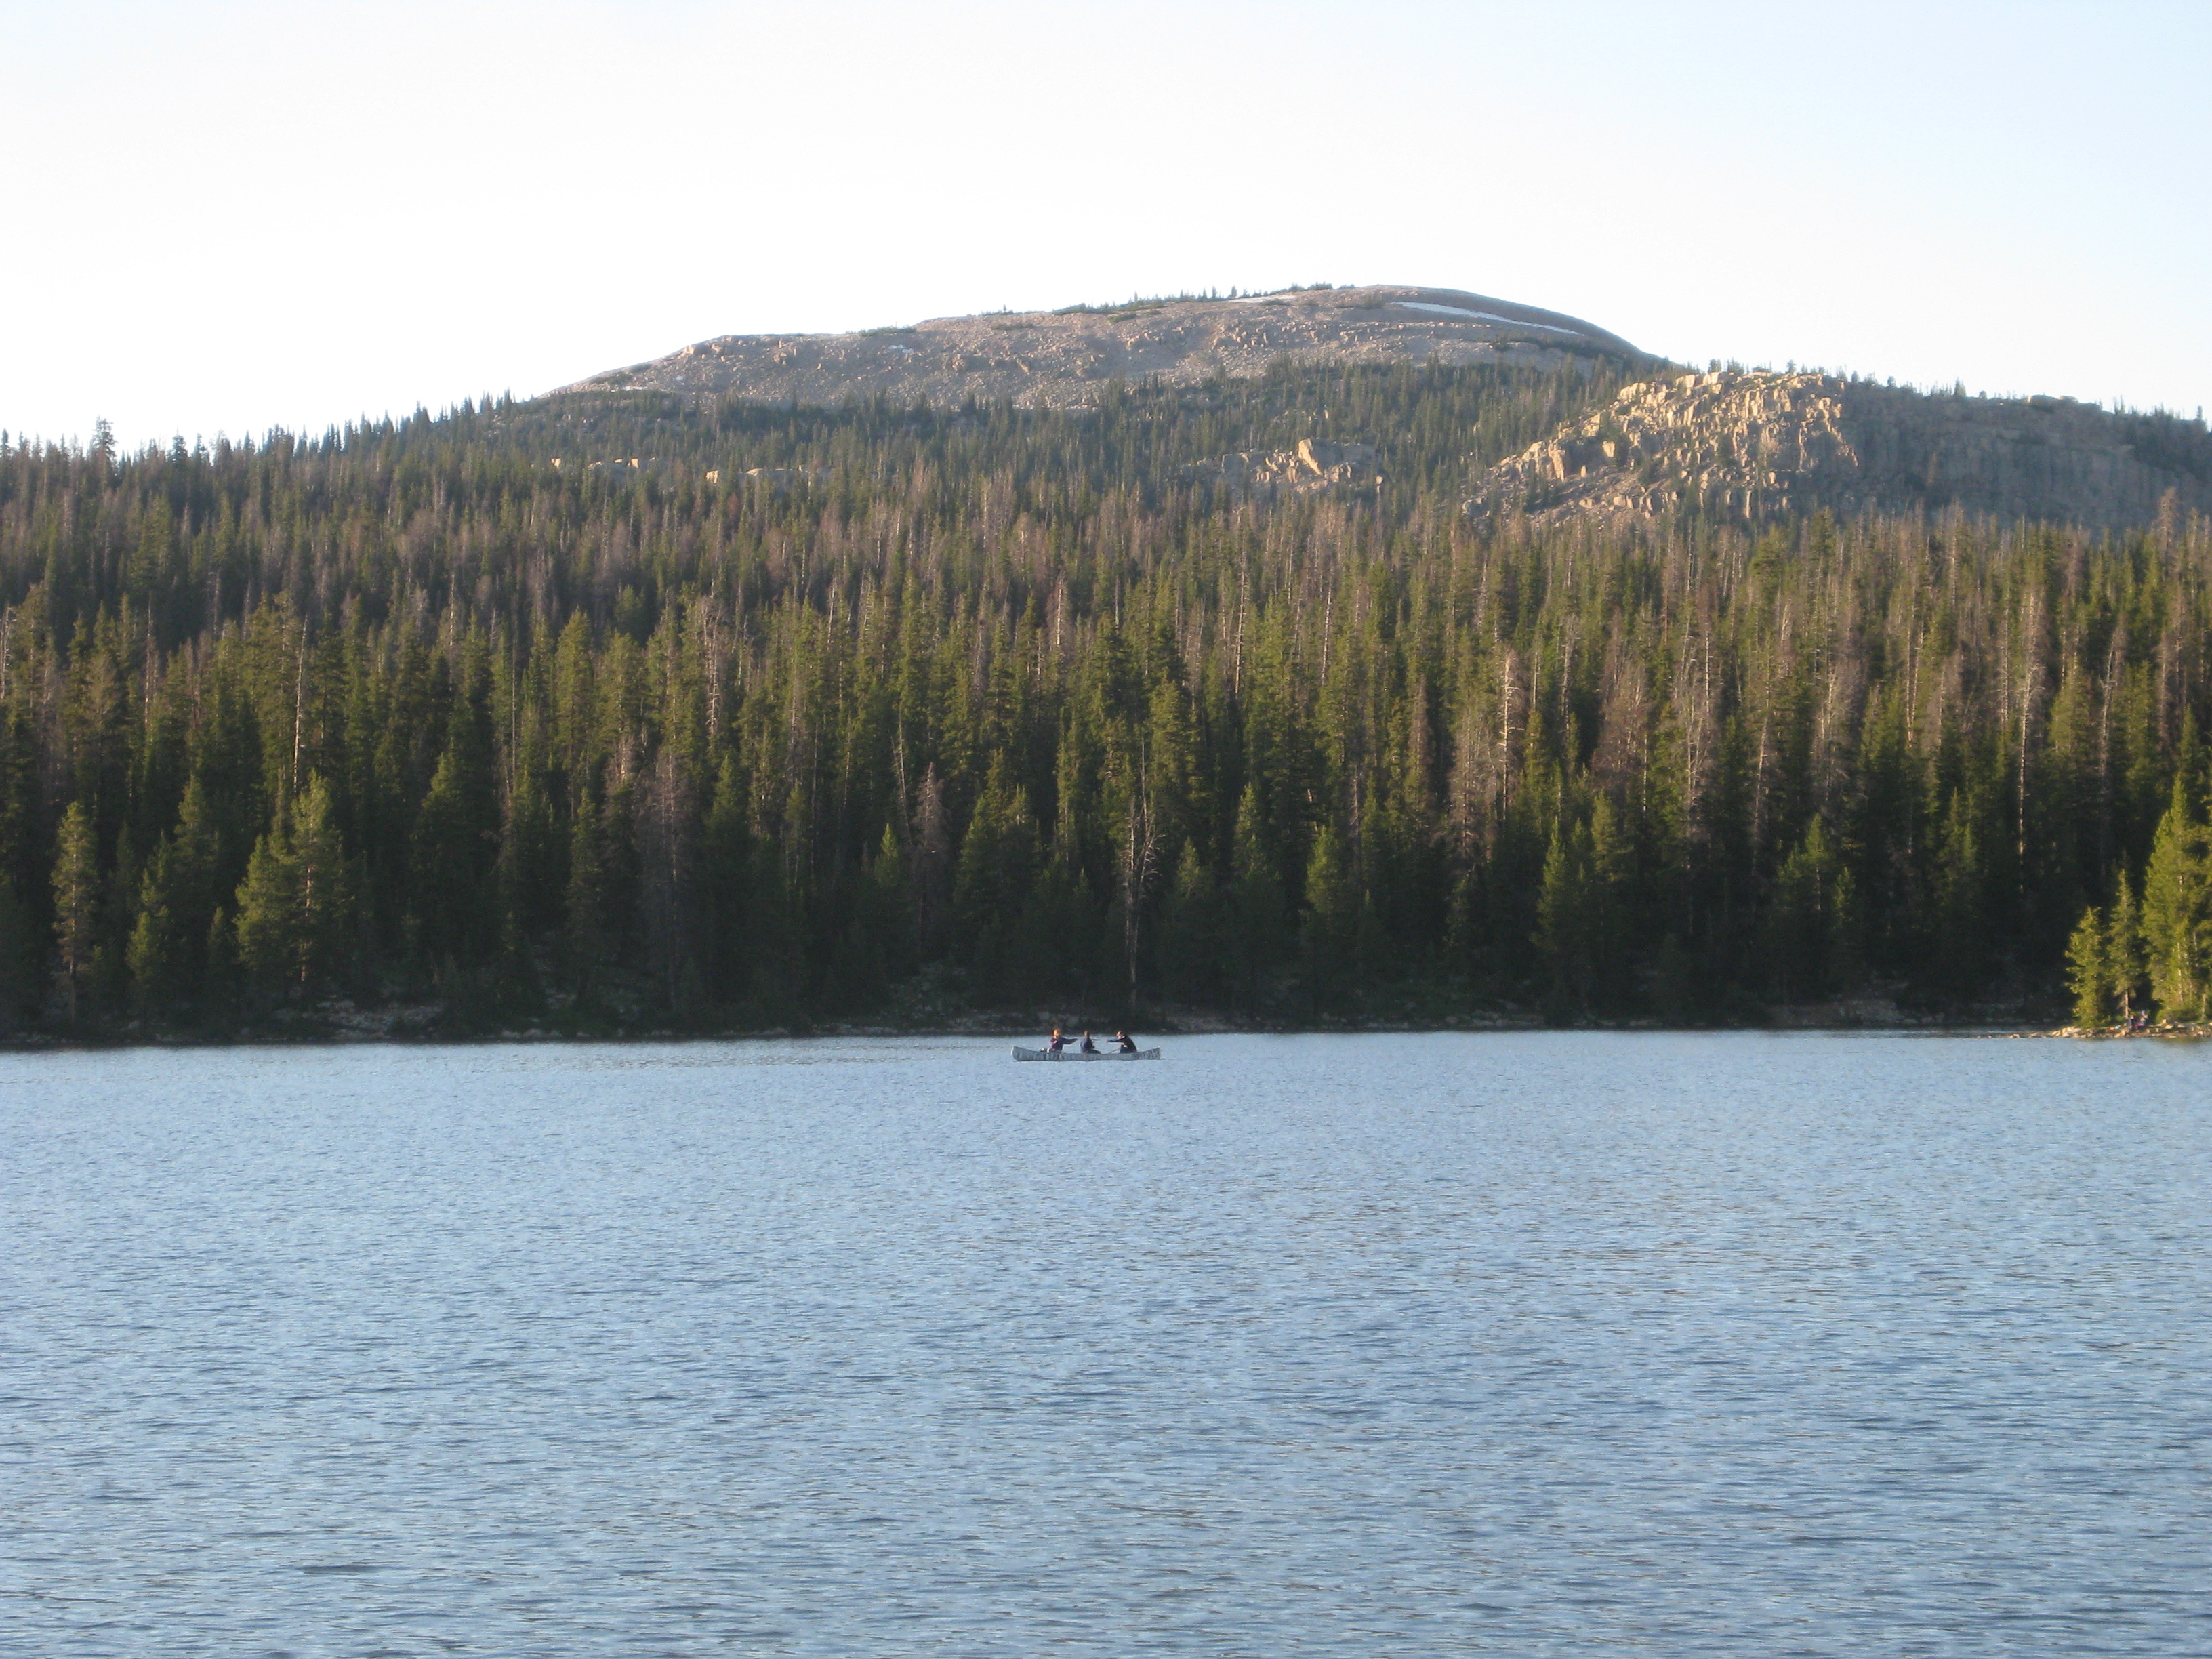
left=562, top=287, right=1641, bottom=409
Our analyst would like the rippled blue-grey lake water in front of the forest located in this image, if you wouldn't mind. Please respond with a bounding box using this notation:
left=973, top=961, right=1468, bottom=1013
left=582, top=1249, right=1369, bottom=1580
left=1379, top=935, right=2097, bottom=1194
left=0, top=1033, right=2212, bottom=1659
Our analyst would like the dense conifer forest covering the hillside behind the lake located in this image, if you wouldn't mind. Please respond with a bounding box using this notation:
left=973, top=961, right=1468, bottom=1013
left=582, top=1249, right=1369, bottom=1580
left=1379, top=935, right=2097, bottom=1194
left=0, top=361, right=2212, bottom=1036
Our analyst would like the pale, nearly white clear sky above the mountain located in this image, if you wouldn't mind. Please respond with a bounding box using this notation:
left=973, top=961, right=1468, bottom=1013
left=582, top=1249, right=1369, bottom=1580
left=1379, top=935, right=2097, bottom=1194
left=0, top=0, right=2212, bottom=447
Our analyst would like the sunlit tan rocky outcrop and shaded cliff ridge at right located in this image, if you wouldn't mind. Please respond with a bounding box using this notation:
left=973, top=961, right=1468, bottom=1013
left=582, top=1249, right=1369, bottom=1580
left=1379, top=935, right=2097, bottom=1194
left=1469, top=371, right=2212, bottom=529
